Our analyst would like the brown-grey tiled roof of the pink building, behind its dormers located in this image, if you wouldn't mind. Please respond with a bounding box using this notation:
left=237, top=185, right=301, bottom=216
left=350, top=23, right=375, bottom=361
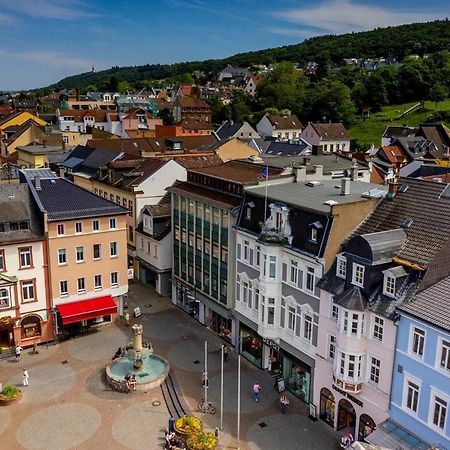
left=353, top=178, right=450, bottom=268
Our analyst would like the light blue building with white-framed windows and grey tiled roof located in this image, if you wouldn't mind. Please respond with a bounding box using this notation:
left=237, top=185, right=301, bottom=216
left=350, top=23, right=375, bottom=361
left=390, top=277, right=450, bottom=450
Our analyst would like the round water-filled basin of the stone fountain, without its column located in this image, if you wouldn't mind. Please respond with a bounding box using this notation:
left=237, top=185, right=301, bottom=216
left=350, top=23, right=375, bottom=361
left=106, top=355, right=170, bottom=392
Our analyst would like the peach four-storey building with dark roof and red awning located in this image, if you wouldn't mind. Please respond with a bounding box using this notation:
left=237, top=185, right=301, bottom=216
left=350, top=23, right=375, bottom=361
left=24, top=170, right=128, bottom=333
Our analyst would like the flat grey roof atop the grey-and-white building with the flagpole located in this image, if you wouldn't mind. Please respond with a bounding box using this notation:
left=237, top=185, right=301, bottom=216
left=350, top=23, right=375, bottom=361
left=246, top=179, right=387, bottom=213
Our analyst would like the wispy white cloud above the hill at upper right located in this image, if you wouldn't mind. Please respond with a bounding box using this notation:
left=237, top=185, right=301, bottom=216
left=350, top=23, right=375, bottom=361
left=273, top=0, right=445, bottom=34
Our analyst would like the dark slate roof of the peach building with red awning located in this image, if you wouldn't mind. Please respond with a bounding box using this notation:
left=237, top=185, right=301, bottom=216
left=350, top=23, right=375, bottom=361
left=28, top=178, right=128, bottom=222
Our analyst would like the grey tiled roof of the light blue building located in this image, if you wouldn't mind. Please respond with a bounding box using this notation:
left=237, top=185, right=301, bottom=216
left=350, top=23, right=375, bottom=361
left=398, top=276, right=450, bottom=331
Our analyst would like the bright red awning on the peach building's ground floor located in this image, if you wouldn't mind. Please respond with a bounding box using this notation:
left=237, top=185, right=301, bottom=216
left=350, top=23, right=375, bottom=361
left=56, top=295, right=117, bottom=325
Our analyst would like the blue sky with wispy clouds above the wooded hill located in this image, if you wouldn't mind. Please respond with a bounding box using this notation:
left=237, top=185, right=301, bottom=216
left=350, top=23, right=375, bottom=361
left=0, top=0, right=450, bottom=90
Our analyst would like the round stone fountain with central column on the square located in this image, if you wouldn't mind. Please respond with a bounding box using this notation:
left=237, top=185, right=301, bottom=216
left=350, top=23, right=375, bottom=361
left=106, top=324, right=170, bottom=392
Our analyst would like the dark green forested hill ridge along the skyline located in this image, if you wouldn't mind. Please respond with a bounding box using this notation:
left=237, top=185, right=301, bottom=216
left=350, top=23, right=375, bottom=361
left=51, top=19, right=450, bottom=88
